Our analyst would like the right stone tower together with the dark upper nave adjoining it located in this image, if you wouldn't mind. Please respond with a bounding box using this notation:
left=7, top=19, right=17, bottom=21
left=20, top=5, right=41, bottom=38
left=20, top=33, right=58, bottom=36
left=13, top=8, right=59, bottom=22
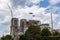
left=20, top=19, right=40, bottom=33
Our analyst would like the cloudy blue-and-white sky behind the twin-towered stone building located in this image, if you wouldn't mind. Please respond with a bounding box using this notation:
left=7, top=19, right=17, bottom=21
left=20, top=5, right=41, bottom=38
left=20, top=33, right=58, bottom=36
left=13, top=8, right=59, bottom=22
left=0, top=0, right=60, bottom=37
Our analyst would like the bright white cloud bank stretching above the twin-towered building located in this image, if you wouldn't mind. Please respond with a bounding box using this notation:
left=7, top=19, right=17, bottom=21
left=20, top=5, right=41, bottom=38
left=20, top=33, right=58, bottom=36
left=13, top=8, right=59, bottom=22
left=14, top=5, right=46, bottom=17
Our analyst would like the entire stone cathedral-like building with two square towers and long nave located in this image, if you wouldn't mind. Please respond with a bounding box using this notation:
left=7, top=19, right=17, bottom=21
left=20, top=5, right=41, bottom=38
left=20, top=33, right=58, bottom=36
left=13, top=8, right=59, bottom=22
left=10, top=18, right=50, bottom=40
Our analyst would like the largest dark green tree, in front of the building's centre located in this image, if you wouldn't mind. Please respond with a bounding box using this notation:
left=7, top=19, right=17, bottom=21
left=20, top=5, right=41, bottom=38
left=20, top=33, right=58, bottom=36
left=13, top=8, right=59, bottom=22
left=25, top=25, right=41, bottom=40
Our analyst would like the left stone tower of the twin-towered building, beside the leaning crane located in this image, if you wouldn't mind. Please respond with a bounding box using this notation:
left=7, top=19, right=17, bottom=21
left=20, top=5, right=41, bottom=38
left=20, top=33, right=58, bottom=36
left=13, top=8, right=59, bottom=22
left=10, top=18, right=19, bottom=40
